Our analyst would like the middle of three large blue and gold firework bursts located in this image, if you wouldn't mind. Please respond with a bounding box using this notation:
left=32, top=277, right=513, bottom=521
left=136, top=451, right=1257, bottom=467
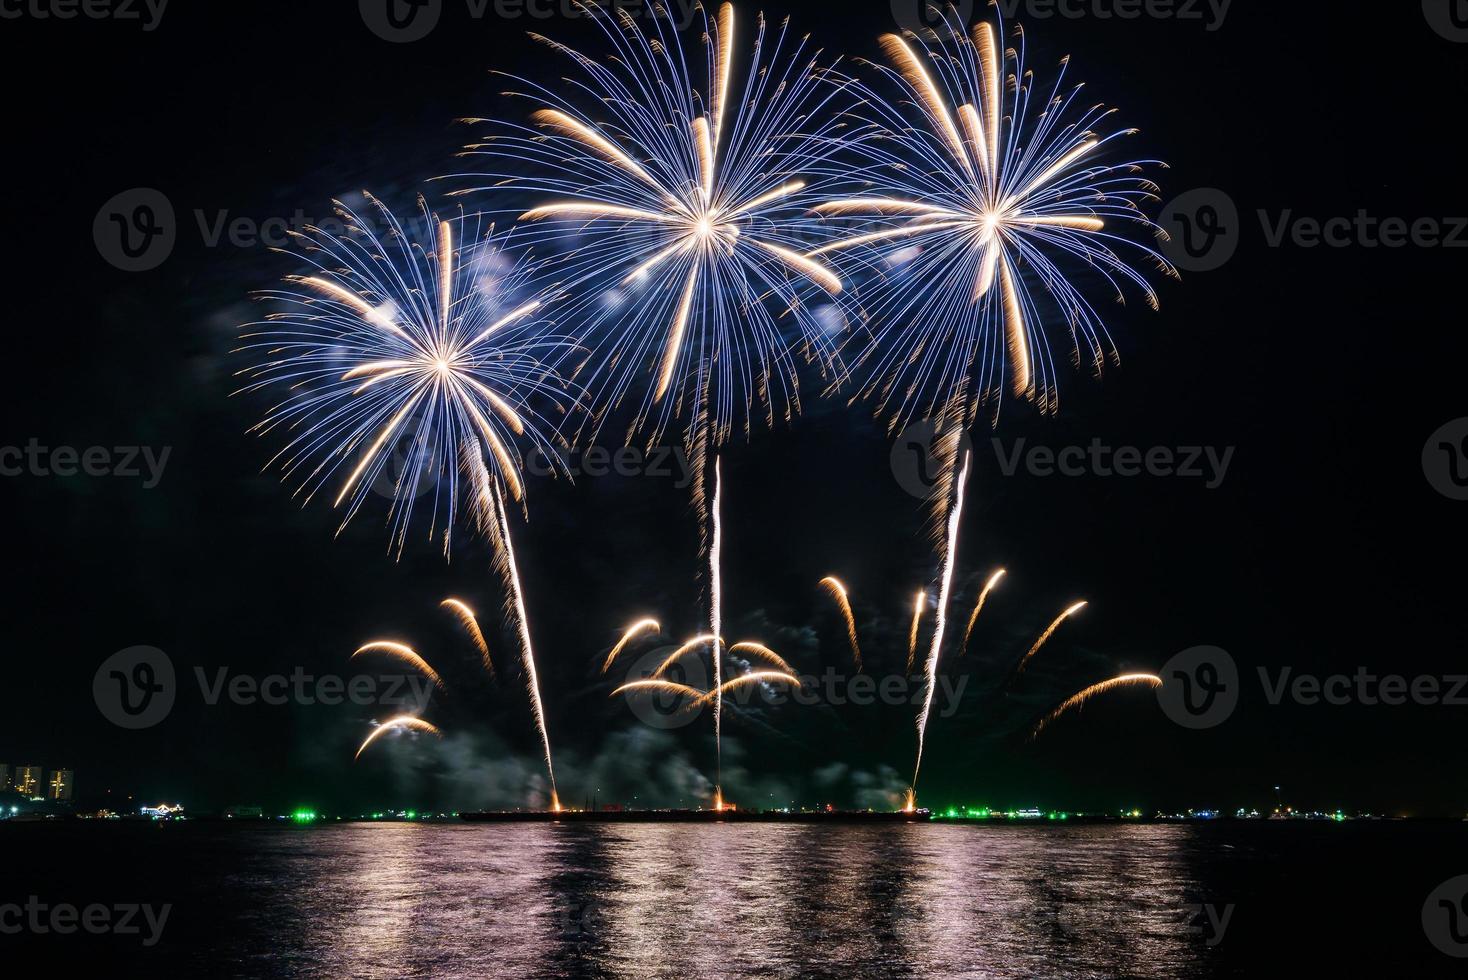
left=452, top=3, right=843, bottom=446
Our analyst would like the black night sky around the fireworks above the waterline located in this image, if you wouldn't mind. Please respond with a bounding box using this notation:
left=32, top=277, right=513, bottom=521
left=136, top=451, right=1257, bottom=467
left=0, top=0, right=1468, bottom=813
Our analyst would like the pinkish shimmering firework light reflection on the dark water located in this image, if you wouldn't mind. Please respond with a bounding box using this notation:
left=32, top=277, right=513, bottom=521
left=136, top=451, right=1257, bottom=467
left=230, top=824, right=1208, bottom=977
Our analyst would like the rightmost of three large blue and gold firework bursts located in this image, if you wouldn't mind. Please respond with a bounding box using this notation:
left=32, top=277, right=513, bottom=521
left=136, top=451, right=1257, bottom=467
left=806, top=6, right=1177, bottom=425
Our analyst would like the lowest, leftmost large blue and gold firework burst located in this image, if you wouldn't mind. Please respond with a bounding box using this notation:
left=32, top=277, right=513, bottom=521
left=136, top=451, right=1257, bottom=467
left=241, top=197, right=570, bottom=555
